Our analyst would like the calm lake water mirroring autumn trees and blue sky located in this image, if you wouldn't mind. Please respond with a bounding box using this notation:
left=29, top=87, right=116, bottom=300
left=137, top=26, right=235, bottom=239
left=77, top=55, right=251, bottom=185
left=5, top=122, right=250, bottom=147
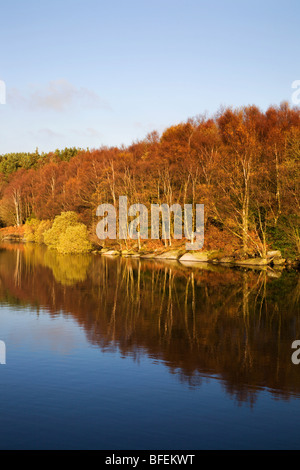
left=0, top=245, right=300, bottom=450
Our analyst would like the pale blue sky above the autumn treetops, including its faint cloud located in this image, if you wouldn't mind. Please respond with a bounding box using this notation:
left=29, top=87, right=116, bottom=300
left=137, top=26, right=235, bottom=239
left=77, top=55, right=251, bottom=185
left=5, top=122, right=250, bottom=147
left=0, top=0, right=300, bottom=154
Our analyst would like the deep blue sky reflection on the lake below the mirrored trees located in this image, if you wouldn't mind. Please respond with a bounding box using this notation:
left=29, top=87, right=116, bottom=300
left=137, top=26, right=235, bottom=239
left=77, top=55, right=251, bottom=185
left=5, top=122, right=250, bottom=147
left=0, top=308, right=299, bottom=449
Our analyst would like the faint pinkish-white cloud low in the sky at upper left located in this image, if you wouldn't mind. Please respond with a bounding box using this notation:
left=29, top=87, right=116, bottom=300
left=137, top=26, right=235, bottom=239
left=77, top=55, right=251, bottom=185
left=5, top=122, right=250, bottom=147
left=8, top=79, right=110, bottom=112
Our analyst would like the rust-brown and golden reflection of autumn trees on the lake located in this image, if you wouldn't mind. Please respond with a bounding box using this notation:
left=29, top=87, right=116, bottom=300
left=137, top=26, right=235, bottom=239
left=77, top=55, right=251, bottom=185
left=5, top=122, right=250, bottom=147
left=0, top=244, right=300, bottom=404
